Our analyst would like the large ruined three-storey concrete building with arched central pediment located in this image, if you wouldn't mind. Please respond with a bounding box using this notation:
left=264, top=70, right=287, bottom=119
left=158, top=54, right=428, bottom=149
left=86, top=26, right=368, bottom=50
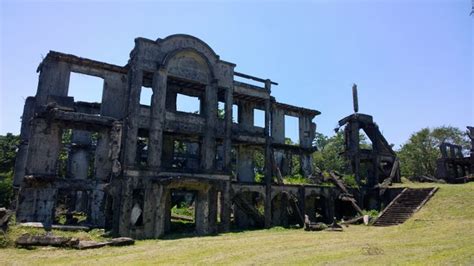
left=14, top=34, right=374, bottom=238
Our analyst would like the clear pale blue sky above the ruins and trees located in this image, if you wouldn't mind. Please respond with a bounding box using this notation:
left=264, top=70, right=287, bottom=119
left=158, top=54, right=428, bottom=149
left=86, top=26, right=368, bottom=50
left=0, top=0, right=474, bottom=147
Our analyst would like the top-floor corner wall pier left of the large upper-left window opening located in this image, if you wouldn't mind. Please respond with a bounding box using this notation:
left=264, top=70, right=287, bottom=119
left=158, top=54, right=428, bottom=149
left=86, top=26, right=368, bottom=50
left=36, top=58, right=71, bottom=105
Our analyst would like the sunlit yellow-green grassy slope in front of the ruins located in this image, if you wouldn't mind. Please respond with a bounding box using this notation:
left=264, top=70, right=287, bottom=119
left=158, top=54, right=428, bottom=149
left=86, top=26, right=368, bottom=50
left=0, top=183, right=474, bottom=265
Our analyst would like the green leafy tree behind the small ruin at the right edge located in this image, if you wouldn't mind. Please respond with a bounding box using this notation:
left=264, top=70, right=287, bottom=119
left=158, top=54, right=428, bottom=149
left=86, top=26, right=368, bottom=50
left=398, top=126, right=469, bottom=176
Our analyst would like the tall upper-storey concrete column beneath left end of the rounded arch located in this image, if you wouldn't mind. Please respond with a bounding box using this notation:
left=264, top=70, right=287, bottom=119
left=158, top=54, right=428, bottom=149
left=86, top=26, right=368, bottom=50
left=148, top=68, right=168, bottom=169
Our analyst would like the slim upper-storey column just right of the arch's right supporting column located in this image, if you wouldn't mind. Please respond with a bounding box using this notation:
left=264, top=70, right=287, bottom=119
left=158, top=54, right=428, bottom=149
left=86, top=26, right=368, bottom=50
left=224, top=87, right=234, bottom=173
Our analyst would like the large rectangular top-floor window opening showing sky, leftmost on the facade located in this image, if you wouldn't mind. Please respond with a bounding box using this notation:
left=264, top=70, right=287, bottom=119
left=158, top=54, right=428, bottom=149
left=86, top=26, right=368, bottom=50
left=68, top=72, right=104, bottom=103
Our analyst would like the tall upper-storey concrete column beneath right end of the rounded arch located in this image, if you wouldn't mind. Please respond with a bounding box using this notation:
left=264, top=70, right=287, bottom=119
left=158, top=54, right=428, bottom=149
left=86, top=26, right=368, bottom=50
left=201, top=83, right=217, bottom=172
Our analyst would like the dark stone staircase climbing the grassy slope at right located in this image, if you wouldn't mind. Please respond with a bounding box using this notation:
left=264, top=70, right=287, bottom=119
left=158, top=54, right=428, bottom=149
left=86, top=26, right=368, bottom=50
left=373, top=188, right=438, bottom=226
